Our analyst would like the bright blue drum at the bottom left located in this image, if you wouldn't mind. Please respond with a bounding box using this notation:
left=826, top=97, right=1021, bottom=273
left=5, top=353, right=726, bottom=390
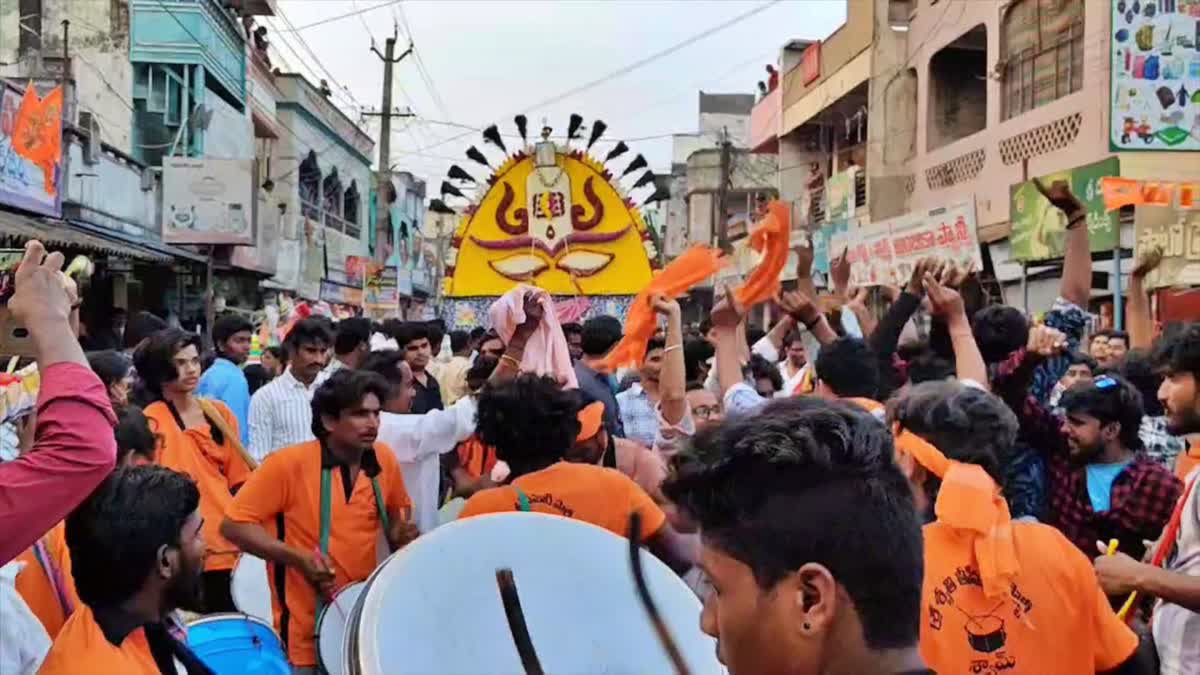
left=187, top=614, right=292, bottom=675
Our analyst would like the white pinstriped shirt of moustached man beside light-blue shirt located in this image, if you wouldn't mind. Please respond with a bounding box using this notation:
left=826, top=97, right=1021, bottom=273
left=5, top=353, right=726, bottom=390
left=246, top=368, right=325, bottom=462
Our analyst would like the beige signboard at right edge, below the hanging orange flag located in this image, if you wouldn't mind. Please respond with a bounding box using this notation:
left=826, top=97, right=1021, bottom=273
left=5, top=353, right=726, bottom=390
left=1133, top=207, right=1200, bottom=288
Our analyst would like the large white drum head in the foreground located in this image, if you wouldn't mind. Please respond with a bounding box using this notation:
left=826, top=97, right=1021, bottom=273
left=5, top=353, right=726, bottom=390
left=347, top=513, right=725, bottom=675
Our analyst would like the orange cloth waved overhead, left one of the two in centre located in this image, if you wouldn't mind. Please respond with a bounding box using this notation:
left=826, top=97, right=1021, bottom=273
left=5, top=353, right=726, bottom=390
left=601, top=245, right=728, bottom=372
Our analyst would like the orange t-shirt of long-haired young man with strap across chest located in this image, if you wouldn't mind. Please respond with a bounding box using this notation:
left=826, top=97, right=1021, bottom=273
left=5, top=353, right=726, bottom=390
left=145, top=401, right=251, bottom=572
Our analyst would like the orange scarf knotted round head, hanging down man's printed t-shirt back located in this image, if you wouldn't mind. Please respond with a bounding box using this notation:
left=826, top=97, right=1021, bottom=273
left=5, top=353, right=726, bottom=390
left=894, top=425, right=1021, bottom=597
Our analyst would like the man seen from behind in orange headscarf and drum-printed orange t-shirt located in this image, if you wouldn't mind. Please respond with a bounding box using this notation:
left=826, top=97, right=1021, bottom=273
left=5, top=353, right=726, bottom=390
left=888, top=381, right=1138, bottom=675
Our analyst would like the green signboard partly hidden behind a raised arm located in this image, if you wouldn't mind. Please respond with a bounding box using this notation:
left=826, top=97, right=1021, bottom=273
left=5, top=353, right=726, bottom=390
left=1009, top=157, right=1121, bottom=262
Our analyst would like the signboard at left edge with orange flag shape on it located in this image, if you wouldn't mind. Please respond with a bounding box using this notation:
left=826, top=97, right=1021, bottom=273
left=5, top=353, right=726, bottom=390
left=0, top=80, right=62, bottom=217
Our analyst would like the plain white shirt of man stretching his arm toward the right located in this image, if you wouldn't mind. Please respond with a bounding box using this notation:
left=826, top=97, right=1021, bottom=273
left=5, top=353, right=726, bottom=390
left=377, top=396, right=476, bottom=532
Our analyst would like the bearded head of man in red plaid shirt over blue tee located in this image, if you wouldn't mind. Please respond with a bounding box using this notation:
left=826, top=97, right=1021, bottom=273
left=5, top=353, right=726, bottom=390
left=1058, top=375, right=1142, bottom=465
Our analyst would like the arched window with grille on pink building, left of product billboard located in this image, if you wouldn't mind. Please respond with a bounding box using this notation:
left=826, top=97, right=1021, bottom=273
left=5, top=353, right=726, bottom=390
left=1000, top=0, right=1084, bottom=119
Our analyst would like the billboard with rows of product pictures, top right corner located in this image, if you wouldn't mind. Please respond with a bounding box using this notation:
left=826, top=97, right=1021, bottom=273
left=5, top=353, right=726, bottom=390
left=1109, top=0, right=1200, bottom=151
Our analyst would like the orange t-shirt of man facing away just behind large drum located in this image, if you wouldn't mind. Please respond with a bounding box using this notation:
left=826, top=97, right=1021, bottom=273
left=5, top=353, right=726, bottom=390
left=458, top=461, right=666, bottom=540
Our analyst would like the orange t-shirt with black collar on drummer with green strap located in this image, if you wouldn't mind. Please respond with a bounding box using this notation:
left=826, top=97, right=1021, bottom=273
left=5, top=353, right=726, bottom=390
left=228, top=441, right=413, bottom=667
